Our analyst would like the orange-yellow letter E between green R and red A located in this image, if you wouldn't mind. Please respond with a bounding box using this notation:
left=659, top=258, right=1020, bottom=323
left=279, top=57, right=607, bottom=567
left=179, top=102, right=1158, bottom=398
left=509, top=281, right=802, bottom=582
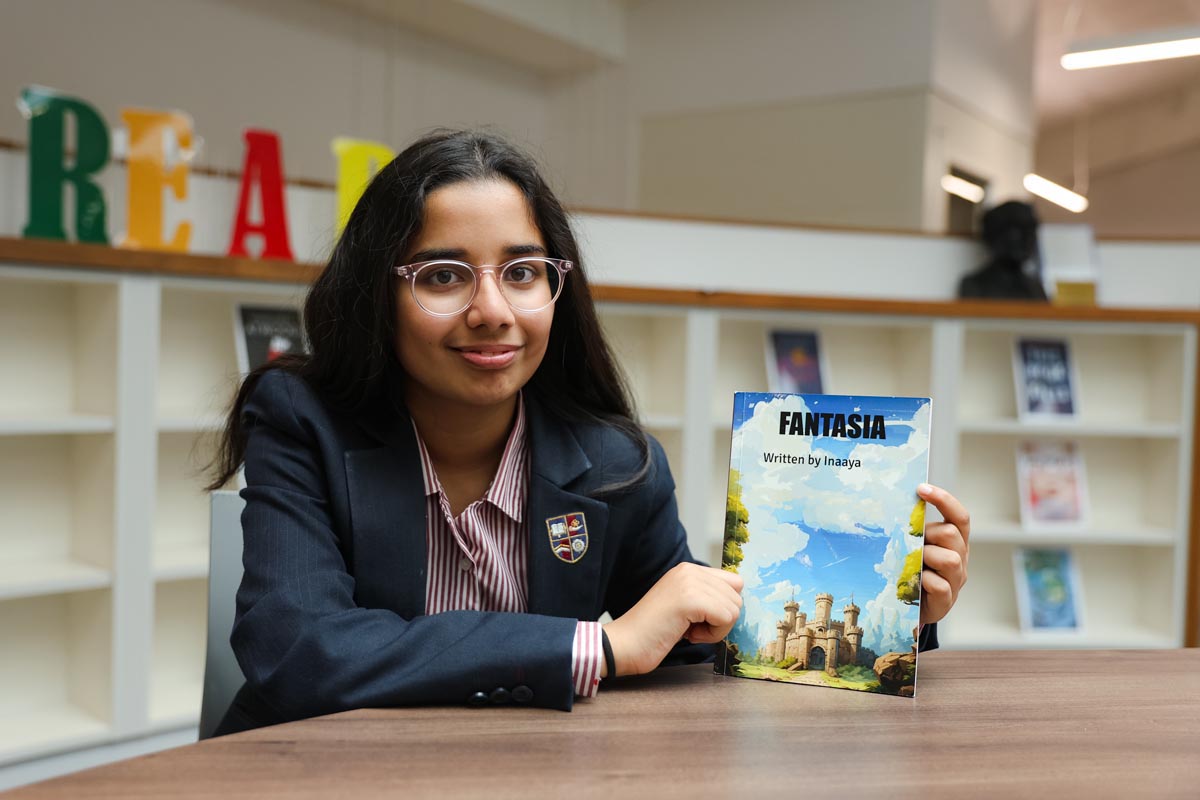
left=121, top=108, right=192, bottom=251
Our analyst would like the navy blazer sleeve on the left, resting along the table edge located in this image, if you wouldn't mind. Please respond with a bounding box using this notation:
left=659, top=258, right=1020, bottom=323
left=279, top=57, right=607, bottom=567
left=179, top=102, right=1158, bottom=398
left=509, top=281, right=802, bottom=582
left=230, top=373, right=576, bottom=720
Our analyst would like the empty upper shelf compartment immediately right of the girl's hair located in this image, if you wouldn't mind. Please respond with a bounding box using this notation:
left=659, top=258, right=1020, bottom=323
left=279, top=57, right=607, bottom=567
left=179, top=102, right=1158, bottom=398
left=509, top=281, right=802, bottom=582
left=599, top=306, right=686, bottom=422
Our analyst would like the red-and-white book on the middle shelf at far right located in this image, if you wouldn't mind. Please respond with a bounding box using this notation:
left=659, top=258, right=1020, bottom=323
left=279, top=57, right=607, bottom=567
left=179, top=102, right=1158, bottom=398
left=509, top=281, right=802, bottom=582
left=1016, top=441, right=1087, bottom=529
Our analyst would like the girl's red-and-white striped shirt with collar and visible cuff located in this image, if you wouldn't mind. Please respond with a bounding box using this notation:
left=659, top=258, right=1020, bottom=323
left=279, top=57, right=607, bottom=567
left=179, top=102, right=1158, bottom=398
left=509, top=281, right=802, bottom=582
left=413, top=395, right=604, bottom=697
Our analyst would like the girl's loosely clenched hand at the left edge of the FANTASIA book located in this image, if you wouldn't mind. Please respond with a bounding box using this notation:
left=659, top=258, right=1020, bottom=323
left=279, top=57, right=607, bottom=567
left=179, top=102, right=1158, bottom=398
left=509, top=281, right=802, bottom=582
left=600, top=564, right=742, bottom=678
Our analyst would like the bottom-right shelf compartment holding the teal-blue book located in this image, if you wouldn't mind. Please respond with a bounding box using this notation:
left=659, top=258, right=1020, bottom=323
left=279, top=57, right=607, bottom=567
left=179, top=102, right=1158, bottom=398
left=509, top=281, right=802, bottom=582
left=938, top=541, right=1182, bottom=649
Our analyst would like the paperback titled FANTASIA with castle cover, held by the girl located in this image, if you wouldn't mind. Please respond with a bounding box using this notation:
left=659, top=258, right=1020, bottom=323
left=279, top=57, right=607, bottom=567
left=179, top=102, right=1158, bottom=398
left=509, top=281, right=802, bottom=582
left=715, top=392, right=932, bottom=697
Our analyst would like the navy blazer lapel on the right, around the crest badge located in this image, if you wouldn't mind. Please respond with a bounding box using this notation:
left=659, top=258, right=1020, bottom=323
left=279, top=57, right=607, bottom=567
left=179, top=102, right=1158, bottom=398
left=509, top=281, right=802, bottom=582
left=526, top=393, right=608, bottom=620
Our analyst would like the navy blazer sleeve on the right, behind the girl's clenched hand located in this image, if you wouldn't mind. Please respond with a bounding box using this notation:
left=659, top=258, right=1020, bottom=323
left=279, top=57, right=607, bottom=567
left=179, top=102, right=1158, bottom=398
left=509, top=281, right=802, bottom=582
left=606, top=434, right=715, bottom=666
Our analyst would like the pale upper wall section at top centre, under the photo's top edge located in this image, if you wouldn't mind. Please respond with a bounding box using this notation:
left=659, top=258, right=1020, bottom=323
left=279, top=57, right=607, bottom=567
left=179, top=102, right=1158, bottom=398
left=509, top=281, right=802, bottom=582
left=628, top=0, right=934, bottom=115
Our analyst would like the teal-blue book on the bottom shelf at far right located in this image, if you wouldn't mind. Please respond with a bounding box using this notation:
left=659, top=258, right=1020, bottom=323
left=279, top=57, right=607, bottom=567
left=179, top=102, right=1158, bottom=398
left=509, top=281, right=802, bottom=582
left=1013, top=547, right=1084, bottom=633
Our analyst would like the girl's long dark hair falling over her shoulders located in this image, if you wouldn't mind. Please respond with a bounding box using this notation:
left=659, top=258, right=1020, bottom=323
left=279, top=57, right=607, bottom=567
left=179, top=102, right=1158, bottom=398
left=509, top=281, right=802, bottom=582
left=208, top=131, right=649, bottom=494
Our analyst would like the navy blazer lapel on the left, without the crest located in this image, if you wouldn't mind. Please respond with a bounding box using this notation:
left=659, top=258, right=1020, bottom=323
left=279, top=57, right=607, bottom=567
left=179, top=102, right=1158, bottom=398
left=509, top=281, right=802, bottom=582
left=346, top=393, right=427, bottom=619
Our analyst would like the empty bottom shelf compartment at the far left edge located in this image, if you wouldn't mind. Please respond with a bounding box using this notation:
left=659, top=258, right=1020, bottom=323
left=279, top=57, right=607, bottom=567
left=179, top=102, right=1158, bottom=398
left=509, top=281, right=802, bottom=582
left=0, top=590, right=112, bottom=763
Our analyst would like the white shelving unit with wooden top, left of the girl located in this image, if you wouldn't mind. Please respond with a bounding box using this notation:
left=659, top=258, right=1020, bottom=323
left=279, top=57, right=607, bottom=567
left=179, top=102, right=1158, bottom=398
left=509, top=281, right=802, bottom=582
left=0, top=265, right=304, bottom=765
